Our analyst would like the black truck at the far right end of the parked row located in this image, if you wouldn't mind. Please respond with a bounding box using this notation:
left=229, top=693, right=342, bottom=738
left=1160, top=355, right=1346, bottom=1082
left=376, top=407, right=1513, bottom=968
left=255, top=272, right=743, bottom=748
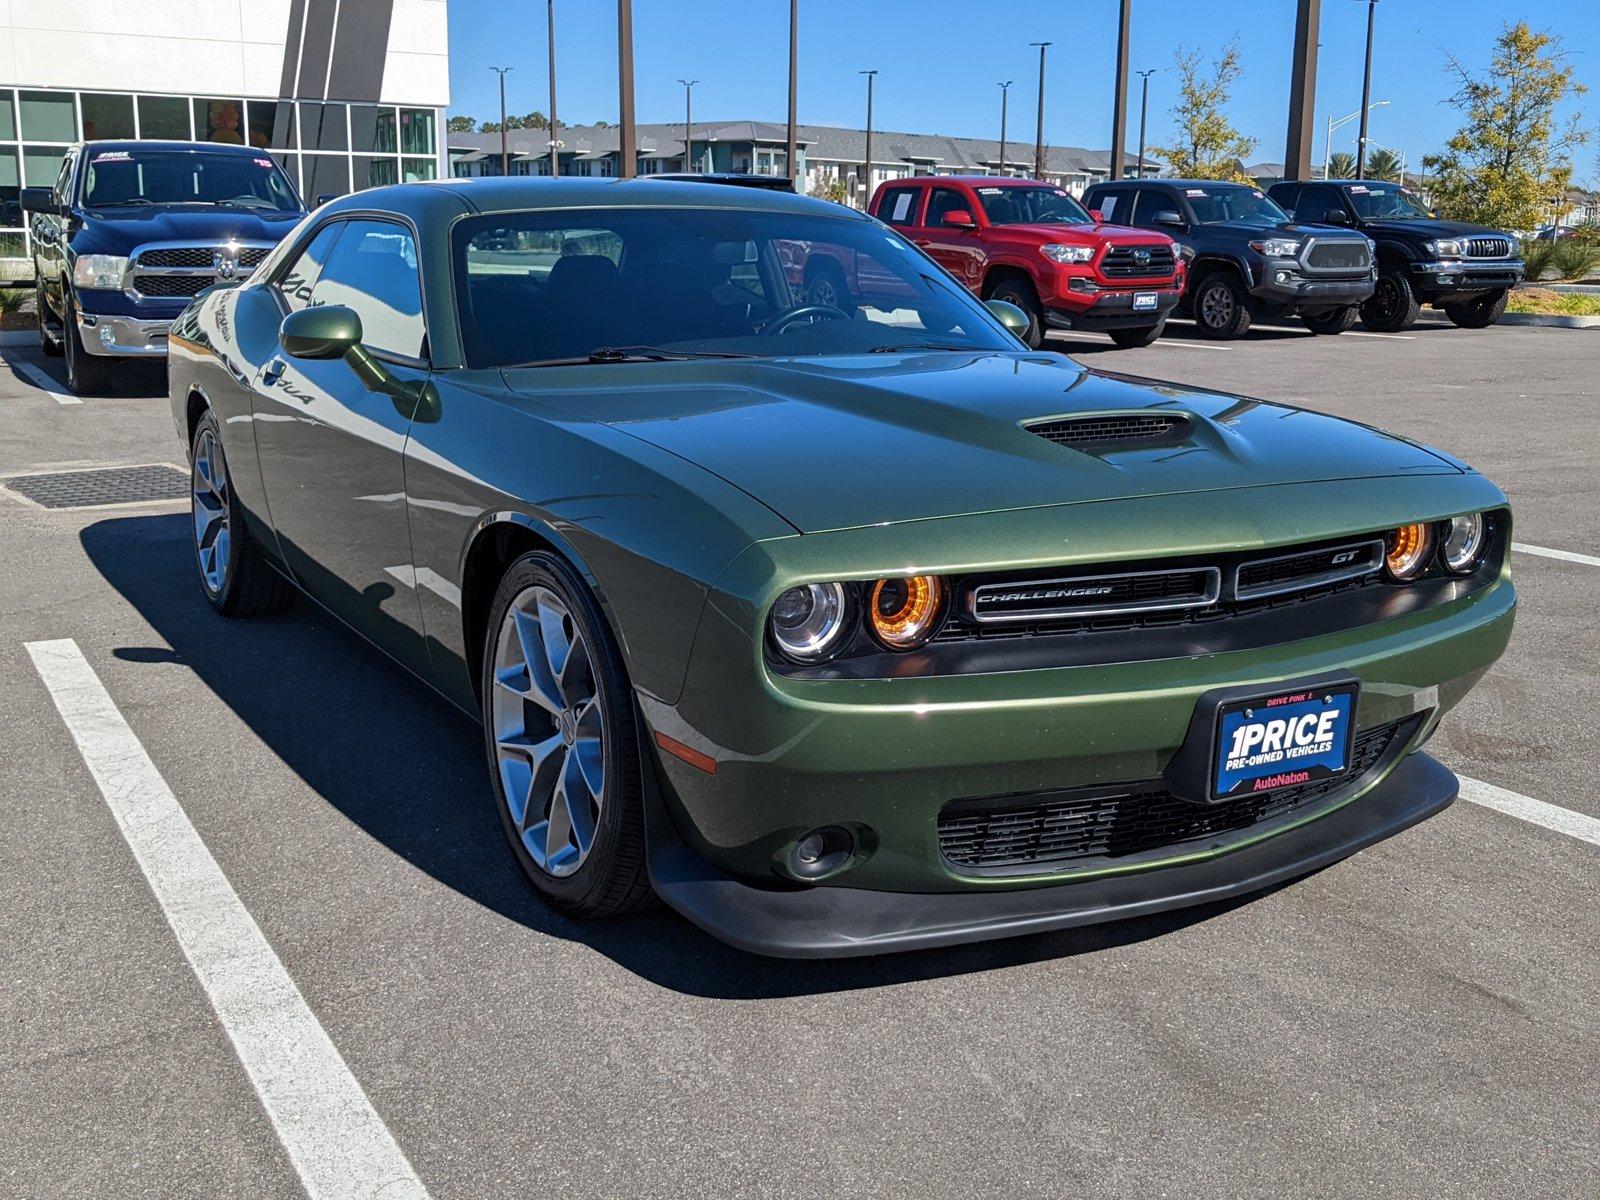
left=1269, top=179, right=1523, bottom=333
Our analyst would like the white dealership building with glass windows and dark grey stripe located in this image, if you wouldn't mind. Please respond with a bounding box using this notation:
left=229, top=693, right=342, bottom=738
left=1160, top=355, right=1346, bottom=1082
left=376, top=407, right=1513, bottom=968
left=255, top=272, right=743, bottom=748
left=0, top=0, right=450, bottom=277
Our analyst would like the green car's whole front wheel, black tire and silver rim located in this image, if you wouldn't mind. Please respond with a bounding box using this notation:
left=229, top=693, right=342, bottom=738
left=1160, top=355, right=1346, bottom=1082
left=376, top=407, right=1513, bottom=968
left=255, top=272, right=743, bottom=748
left=482, top=550, right=650, bottom=918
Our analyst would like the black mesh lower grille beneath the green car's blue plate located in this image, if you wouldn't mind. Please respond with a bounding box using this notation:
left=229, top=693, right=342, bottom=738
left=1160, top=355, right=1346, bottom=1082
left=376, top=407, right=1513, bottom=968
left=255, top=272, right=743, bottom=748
left=939, top=717, right=1418, bottom=874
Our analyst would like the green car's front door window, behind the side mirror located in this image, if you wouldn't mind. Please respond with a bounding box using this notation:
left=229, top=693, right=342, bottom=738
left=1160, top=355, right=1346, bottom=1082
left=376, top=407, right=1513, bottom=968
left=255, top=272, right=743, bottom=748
left=310, top=221, right=427, bottom=358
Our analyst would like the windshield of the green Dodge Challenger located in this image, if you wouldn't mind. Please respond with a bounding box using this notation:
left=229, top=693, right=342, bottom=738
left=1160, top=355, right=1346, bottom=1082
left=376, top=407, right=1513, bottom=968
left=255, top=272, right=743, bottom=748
left=451, top=208, right=1018, bottom=366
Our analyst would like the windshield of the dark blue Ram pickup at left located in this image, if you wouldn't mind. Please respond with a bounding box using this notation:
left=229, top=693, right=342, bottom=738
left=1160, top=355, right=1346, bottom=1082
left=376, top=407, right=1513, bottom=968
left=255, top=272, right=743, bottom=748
left=83, top=146, right=299, bottom=213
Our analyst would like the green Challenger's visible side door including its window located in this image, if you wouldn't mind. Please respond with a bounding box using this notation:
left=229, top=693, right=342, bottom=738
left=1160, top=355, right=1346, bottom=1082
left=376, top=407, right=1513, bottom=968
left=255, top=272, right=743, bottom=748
left=253, top=218, right=429, bottom=669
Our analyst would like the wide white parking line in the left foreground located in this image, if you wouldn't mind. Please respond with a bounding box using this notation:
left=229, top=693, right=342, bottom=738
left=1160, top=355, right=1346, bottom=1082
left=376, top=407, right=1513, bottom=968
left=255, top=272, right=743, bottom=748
left=27, top=638, right=427, bottom=1200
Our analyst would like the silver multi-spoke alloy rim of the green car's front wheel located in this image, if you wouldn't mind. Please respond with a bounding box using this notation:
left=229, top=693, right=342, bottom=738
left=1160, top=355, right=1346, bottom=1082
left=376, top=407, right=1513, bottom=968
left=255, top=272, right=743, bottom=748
left=490, top=586, right=606, bottom=877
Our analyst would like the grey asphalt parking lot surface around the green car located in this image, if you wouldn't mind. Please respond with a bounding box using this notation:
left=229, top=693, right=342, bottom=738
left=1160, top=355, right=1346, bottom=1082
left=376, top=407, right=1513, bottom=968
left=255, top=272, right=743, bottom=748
left=0, top=322, right=1600, bottom=1200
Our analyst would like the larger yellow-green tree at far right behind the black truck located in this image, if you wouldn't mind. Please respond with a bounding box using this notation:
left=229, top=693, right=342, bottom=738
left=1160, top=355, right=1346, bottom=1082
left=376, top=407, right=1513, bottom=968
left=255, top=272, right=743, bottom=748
left=1422, top=21, right=1589, bottom=229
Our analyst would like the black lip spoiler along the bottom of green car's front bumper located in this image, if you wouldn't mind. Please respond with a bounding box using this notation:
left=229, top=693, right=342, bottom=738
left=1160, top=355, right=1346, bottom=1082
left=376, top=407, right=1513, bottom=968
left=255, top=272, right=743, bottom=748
left=650, top=754, right=1456, bottom=958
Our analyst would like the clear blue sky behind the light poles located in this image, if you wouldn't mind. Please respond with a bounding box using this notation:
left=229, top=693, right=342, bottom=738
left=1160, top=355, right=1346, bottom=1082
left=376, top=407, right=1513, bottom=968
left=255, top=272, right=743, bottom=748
left=450, top=0, right=1600, bottom=179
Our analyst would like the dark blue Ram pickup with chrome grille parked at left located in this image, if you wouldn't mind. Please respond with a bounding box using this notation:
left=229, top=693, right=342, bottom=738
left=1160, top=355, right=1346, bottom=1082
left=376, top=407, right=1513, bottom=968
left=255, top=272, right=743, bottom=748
left=21, top=141, right=306, bottom=394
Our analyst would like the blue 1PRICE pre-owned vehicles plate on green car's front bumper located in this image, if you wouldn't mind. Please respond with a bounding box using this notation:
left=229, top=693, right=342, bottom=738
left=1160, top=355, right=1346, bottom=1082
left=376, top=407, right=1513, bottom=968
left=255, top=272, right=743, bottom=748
left=1211, top=683, right=1358, bottom=800
